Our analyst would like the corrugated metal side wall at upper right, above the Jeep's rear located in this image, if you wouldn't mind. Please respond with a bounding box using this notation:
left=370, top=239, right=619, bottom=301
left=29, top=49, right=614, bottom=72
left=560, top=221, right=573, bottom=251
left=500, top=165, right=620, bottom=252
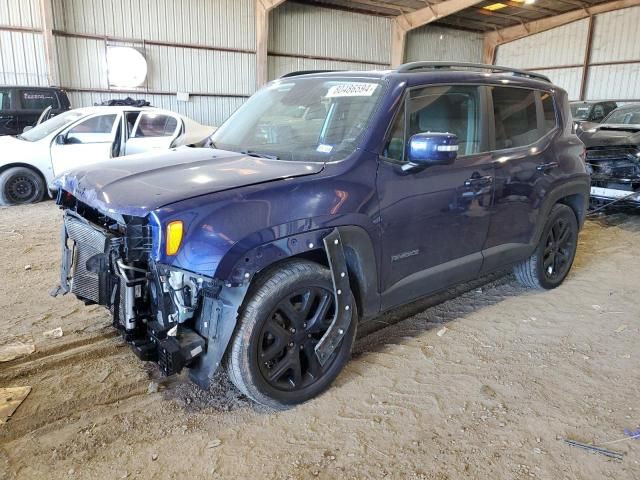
left=495, top=7, right=640, bottom=101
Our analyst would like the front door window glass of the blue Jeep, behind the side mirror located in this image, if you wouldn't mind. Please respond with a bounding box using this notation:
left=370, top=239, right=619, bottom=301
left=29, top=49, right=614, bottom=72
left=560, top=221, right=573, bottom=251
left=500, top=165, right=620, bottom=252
left=407, top=85, right=480, bottom=156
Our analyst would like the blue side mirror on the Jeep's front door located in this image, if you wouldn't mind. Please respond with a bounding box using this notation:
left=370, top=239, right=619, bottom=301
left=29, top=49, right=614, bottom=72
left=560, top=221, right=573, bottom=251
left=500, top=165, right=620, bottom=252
left=403, top=132, right=459, bottom=171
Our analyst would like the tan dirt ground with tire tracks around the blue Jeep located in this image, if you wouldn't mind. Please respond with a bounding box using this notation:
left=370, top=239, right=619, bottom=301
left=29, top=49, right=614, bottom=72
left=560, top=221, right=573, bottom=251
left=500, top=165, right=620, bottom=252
left=0, top=202, right=640, bottom=480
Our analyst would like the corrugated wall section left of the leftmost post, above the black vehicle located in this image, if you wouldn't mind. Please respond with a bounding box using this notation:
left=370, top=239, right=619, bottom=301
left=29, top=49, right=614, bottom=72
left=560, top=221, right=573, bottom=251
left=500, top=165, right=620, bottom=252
left=0, top=0, right=48, bottom=85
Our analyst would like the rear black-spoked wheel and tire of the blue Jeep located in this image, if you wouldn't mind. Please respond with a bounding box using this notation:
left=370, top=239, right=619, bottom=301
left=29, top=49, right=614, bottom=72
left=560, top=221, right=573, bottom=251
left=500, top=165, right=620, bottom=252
left=513, top=203, right=578, bottom=290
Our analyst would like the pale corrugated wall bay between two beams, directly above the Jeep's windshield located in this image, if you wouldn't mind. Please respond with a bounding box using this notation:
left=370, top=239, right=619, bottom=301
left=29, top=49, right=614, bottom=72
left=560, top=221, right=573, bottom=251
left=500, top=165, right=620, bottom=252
left=269, top=2, right=391, bottom=79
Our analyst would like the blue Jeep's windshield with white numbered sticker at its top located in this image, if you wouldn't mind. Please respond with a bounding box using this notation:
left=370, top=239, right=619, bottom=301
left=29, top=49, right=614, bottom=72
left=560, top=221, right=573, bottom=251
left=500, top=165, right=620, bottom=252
left=211, top=78, right=382, bottom=161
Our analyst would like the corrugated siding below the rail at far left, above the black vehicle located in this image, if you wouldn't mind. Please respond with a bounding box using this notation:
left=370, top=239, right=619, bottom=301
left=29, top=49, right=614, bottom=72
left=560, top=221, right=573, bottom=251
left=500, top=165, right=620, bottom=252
left=0, top=31, right=48, bottom=86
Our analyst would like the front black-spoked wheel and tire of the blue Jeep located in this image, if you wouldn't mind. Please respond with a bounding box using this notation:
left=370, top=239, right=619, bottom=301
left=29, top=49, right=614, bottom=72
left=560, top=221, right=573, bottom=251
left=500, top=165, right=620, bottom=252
left=226, top=260, right=357, bottom=410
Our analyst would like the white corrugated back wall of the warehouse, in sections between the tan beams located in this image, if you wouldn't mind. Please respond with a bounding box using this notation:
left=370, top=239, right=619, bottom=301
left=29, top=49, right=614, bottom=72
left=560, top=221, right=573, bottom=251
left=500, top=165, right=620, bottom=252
left=0, top=0, right=482, bottom=125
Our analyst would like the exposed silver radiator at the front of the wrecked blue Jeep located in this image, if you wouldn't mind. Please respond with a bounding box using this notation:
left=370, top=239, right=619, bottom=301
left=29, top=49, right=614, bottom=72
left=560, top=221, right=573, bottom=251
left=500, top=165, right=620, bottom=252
left=64, top=215, right=109, bottom=303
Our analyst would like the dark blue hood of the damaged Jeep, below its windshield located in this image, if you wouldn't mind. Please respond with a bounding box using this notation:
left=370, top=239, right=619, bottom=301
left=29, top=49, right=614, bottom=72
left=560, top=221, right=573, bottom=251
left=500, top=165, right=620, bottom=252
left=54, top=147, right=324, bottom=217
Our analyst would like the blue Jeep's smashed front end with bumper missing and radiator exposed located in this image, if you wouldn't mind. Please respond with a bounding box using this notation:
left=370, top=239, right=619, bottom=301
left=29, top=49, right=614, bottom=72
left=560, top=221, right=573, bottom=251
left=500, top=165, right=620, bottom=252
left=52, top=190, right=247, bottom=388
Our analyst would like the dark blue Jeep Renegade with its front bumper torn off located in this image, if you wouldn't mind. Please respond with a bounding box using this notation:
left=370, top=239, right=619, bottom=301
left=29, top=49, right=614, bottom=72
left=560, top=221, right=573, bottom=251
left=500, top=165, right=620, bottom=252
left=54, top=62, right=589, bottom=408
